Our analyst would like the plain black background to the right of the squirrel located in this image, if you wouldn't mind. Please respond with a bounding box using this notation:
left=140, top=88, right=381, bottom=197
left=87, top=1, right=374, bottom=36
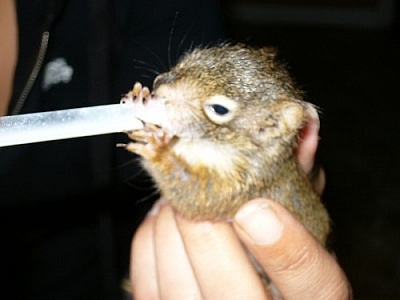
left=223, top=0, right=400, bottom=300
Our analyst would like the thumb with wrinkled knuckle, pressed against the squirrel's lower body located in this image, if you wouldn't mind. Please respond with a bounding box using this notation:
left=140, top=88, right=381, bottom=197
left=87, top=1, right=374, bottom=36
left=234, top=199, right=350, bottom=300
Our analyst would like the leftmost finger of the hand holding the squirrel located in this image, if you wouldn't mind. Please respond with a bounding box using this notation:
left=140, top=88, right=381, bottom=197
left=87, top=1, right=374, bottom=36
left=130, top=212, right=159, bottom=300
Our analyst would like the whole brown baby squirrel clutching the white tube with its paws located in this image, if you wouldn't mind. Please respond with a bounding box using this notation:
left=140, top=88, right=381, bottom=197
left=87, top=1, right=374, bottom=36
left=122, top=44, right=330, bottom=245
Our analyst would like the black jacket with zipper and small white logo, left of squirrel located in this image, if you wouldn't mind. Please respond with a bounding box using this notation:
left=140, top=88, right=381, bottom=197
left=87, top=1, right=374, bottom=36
left=0, top=0, right=222, bottom=299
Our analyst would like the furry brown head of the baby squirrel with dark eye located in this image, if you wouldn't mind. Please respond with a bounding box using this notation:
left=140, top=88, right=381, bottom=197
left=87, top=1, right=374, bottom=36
left=153, top=44, right=315, bottom=162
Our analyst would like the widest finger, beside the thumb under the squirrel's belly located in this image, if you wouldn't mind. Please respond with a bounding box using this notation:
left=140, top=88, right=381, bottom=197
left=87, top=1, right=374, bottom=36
left=177, top=216, right=269, bottom=299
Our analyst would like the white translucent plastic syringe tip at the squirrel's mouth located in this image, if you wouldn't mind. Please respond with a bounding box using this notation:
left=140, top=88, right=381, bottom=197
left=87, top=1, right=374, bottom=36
left=0, top=103, right=148, bottom=147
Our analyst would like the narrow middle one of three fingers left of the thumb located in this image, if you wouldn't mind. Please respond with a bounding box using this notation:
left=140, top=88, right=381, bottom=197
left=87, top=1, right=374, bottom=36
left=154, top=205, right=202, bottom=299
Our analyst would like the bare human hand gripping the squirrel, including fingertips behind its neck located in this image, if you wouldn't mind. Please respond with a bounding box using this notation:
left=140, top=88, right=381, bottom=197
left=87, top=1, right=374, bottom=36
left=130, top=118, right=351, bottom=300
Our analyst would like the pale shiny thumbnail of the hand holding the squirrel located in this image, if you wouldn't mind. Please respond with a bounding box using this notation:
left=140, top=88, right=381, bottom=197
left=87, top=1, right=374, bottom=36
left=235, top=202, right=283, bottom=245
